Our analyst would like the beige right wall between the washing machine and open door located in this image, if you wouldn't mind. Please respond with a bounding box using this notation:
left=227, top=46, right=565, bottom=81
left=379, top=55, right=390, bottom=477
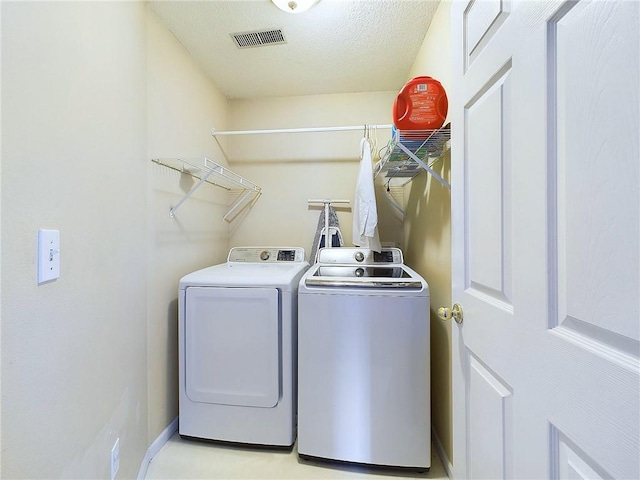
left=404, top=0, right=453, bottom=462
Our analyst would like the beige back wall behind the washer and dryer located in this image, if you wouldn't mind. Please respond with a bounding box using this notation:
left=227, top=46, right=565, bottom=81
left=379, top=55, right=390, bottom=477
left=226, top=92, right=402, bottom=256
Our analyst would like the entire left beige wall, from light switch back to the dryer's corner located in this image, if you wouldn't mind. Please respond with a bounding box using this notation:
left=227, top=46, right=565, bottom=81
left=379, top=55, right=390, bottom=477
left=1, top=2, right=228, bottom=478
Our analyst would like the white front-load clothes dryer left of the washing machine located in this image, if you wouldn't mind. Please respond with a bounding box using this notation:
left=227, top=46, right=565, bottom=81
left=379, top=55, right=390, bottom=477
left=178, top=247, right=309, bottom=446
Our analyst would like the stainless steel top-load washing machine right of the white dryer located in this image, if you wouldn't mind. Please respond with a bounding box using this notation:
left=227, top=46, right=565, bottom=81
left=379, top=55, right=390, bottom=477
left=298, top=248, right=431, bottom=470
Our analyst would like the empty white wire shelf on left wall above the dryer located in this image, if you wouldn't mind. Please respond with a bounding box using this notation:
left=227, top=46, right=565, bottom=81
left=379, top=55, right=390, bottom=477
left=151, top=157, right=262, bottom=222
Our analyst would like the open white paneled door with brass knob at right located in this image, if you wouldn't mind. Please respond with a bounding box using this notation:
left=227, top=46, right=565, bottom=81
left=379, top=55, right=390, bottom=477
left=451, top=0, right=640, bottom=479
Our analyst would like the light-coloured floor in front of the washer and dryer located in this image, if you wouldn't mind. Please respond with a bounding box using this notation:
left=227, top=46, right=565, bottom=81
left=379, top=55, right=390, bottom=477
left=145, top=433, right=448, bottom=480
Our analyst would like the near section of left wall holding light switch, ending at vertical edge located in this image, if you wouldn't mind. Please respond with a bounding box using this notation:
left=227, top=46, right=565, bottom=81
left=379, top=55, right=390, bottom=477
left=2, top=2, right=148, bottom=478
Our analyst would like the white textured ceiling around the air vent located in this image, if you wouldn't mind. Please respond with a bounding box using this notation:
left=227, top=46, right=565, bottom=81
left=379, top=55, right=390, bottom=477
left=151, top=0, right=438, bottom=98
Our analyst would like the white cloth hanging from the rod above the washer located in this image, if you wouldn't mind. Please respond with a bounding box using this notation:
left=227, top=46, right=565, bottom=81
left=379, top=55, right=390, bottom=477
left=353, top=137, right=381, bottom=252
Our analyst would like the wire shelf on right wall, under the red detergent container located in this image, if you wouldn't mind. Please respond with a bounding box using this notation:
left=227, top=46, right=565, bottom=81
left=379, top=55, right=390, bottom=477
left=374, top=124, right=451, bottom=190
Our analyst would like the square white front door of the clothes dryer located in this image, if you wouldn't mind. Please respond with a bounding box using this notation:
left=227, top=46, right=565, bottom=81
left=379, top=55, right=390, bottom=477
left=185, top=287, right=281, bottom=407
